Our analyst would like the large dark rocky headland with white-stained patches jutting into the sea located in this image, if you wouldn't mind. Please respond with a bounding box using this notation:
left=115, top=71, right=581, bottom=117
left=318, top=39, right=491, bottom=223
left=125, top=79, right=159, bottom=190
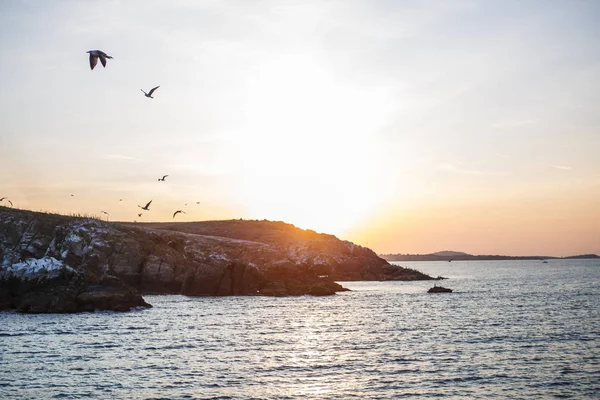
left=0, top=207, right=432, bottom=312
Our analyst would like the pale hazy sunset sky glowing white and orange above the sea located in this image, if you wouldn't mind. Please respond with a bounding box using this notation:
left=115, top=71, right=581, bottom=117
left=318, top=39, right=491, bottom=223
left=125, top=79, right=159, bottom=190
left=0, top=0, right=600, bottom=256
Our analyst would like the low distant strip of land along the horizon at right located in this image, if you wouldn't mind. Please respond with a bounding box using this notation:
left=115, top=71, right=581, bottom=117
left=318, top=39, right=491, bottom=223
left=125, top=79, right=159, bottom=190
left=379, top=251, right=600, bottom=261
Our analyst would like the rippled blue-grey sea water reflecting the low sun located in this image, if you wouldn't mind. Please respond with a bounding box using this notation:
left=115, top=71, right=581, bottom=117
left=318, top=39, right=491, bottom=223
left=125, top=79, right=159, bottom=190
left=0, top=260, right=600, bottom=399
